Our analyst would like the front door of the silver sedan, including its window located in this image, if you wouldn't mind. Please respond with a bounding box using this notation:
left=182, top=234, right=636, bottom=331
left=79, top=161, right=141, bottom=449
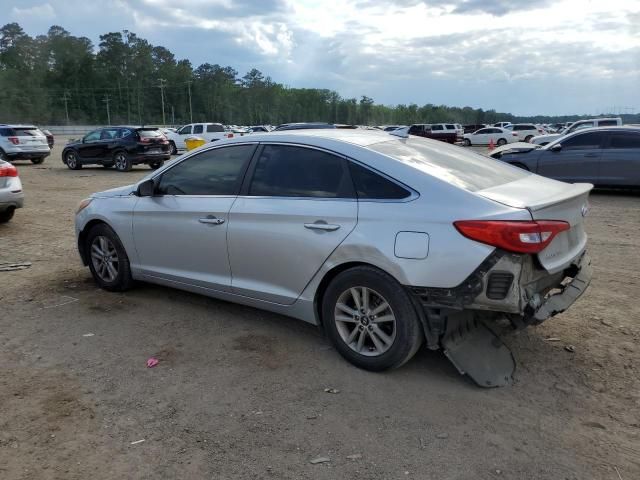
left=133, top=144, right=256, bottom=291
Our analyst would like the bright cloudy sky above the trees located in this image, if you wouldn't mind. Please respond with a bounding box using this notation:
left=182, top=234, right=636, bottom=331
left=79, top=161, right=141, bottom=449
left=6, top=0, right=640, bottom=115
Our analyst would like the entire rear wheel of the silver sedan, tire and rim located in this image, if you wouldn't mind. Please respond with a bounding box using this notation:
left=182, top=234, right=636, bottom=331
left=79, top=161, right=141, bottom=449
left=322, top=267, right=424, bottom=371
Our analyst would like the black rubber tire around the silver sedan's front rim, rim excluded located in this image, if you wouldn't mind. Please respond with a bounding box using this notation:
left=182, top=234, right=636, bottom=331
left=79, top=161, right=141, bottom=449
left=84, top=223, right=133, bottom=292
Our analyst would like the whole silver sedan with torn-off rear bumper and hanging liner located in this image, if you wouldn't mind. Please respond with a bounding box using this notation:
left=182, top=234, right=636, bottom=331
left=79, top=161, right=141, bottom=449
left=76, top=129, right=592, bottom=386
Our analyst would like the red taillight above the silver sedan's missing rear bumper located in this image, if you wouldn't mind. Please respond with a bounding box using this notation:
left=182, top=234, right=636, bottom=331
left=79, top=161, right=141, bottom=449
left=453, top=220, right=570, bottom=253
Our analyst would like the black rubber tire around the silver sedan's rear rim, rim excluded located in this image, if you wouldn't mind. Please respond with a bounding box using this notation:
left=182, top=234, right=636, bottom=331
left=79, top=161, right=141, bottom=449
left=322, top=266, right=424, bottom=371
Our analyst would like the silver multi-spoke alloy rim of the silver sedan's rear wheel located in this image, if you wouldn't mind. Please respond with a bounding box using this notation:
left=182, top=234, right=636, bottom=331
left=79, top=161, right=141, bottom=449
left=333, top=287, right=396, bottom=357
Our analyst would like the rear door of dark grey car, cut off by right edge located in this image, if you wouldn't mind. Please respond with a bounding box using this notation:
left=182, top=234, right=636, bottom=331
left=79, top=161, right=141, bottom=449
left=599, top=131, right=640, bottom=187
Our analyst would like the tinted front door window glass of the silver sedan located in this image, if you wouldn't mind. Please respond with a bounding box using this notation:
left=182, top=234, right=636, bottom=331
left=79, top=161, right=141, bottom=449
left=157, top=145, right=256, bottom=195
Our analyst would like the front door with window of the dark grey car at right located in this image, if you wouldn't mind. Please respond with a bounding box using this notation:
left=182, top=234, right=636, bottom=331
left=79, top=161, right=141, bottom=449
left=536, top=131, right=606, bottom=184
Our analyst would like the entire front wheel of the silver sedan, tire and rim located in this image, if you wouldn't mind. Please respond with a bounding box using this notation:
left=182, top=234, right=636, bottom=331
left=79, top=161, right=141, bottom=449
left=85, top=223, right=133, bottom=292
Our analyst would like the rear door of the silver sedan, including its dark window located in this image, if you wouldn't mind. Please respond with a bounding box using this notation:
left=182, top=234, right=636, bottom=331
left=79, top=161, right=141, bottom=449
left=229, top=144, right=358, bottom=305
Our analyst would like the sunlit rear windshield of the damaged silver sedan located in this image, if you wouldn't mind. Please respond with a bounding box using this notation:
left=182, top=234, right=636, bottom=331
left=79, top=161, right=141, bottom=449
left=369, top=138, right=531, bottom=192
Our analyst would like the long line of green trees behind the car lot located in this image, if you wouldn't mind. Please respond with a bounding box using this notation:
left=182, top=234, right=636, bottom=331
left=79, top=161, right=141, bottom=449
left=0, top=23, right=640, bottom=125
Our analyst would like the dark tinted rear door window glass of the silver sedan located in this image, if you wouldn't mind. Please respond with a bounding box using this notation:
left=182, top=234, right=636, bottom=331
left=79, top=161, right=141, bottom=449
left=249, top=145, right=354, bottom=198
